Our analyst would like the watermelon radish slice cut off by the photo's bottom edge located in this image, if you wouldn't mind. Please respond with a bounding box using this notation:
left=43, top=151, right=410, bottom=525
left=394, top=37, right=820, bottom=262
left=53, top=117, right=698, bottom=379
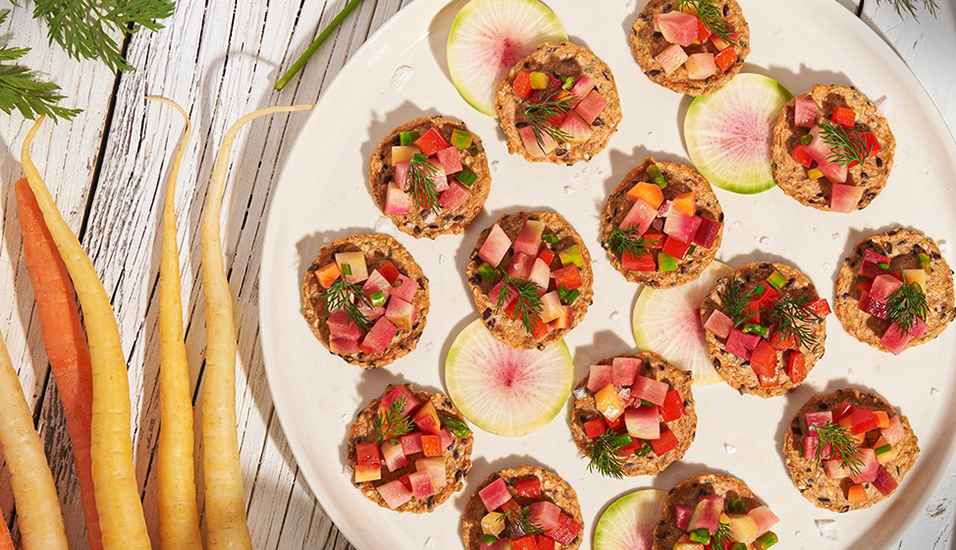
left=594, top=489, right=667, bottom=550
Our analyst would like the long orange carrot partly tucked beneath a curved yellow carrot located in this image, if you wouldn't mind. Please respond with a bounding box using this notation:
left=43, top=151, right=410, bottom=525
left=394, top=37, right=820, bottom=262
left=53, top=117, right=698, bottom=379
left=15, top=179, right=103, bottom=550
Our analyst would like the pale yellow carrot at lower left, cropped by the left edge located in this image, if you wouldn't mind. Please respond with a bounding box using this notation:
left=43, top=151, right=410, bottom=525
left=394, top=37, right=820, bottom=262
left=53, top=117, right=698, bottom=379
left=0, top=332, right=69, bottom=550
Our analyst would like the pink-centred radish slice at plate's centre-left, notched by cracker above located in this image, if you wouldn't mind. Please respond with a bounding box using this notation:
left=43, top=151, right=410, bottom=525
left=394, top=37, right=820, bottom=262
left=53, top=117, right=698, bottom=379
left=445, top=319, right=574, bottom=436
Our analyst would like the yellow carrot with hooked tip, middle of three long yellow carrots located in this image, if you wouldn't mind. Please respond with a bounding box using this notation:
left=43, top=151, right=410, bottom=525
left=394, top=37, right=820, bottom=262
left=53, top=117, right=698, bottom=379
left=147, top=97, right=202, bottom=550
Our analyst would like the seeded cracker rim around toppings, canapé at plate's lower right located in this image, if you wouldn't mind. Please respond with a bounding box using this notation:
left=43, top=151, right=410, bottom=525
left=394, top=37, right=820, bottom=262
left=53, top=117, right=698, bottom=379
left=783, top=389, right=919, bottom=514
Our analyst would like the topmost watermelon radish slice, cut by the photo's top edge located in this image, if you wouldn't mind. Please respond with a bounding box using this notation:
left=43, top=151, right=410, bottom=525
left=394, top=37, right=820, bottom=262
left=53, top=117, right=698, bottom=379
left=447, top=0, right=568, bottom=116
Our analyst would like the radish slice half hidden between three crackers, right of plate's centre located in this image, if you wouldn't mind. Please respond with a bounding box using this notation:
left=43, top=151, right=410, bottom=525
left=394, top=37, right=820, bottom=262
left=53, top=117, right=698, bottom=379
left=631, top=261, right=734, bottom=386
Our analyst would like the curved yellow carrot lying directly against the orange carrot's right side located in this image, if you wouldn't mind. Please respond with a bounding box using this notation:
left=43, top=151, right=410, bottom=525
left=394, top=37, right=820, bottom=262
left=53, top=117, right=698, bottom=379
left=21, top=117, right=151, bottom=550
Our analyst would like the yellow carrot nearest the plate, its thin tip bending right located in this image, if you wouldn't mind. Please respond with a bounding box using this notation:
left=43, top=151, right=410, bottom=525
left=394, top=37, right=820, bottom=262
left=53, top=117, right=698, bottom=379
left=202, top=105, right=312, bottom=550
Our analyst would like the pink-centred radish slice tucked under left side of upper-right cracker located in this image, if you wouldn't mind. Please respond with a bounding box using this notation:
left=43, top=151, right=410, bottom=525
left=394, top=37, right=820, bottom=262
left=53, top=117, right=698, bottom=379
left=684, top=74, right=793, bottom=194
